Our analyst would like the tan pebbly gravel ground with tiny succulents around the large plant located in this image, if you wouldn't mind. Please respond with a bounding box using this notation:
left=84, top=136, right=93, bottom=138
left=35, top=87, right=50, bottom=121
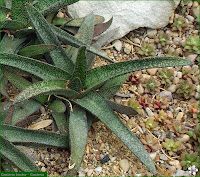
left=2, top=1, right=199, bottom=176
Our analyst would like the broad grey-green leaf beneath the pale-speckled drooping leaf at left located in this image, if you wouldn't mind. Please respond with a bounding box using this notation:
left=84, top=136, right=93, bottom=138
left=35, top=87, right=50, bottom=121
left=12, top=99, right=42, bottom=125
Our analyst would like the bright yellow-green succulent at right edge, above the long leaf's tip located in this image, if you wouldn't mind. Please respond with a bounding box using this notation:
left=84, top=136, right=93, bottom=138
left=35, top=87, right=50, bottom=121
left=182, top=35, right=199, bottom=53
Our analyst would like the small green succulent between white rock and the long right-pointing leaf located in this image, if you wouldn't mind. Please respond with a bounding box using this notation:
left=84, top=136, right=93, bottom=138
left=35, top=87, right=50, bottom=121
left=136, top=43, right=155, bottom=57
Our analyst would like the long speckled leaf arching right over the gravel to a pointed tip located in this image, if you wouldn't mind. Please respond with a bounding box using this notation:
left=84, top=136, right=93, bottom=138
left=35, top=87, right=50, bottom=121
left=86, top=57, right=192, bottom=88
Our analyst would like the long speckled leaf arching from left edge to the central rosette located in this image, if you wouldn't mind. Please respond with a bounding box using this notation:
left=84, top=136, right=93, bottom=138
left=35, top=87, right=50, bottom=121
left=1, top=53, right=71, bottom=80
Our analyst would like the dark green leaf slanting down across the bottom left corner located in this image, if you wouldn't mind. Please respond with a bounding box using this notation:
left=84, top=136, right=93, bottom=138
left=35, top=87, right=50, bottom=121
left=1, top=136, right=39, bottom=172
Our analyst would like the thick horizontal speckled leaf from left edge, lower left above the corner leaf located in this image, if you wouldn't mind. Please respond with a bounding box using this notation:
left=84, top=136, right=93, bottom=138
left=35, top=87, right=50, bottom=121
left=1, top=125, right=69, bottom=148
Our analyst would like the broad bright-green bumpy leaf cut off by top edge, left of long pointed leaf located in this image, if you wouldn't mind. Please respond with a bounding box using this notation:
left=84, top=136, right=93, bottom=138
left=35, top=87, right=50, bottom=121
left=11, top=1, right=29, bottom=23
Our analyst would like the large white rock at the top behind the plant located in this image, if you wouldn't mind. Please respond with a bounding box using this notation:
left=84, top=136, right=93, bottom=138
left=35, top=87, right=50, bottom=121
left=67, top=1, right=179, bottom=43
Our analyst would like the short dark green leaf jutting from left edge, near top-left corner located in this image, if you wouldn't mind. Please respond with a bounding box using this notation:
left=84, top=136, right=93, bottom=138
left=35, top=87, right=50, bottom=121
left=1, top=20, right=26, bottom=31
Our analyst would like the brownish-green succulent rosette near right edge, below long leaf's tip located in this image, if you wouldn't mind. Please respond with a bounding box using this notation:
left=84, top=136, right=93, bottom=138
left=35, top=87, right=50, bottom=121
left=176, top=80, right=195, bottom=99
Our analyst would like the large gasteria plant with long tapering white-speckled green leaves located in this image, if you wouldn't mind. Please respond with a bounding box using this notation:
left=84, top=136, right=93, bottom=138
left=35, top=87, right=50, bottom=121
left=1, top=1, right=191, bottom=175
